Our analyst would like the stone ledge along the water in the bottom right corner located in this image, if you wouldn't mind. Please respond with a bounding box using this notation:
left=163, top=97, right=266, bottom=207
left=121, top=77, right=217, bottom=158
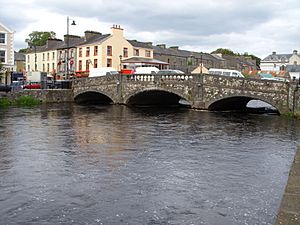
left=276, top=146, right=300, bottom=225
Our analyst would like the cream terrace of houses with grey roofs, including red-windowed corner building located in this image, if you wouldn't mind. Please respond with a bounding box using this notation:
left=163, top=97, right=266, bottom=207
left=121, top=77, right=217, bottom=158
left=26, top=25, right=158, bottom=78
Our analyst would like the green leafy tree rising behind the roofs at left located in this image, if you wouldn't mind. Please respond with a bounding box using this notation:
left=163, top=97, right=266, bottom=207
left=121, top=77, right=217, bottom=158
left=25, top=31, right=56, bottom=46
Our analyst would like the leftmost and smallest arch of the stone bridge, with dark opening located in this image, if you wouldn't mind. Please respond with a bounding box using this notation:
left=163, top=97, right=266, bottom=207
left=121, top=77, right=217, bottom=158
left=74, top=90, right=114, bottom=104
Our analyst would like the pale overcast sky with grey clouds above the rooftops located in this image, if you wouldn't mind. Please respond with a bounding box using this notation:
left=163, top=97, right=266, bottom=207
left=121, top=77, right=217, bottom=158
left=0, top=0, right=300, bottom=58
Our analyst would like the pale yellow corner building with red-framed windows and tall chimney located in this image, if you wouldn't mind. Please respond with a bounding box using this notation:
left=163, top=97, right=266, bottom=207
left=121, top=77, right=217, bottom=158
left=76, top=25, right=153, bottom=77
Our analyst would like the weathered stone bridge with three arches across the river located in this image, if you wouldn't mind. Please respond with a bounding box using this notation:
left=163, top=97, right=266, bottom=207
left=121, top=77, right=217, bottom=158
left=73, top=74, right=300, bottom=113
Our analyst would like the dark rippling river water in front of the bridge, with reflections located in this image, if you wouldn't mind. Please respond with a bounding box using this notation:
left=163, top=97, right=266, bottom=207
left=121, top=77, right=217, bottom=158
left=0, top=104, right=300, bottom=225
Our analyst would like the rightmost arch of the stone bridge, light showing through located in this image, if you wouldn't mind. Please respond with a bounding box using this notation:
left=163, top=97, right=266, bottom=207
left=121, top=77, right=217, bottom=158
left=207, top=95, right=281, bottom=114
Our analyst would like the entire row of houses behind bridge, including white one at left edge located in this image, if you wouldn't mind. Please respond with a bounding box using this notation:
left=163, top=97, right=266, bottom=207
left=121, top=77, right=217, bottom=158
left=0, top=24, right=256, bottom=79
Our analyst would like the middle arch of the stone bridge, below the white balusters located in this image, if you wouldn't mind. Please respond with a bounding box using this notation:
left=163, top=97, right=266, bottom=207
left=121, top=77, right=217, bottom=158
left=124, top=88, right=189, bottom=105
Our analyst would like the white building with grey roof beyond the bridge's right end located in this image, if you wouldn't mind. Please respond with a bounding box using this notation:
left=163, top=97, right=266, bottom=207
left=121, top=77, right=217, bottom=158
left=260, top=50, right=300, bottom=72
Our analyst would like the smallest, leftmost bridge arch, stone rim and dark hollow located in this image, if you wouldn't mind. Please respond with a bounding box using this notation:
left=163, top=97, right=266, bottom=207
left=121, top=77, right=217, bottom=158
left=73, top=89, right=116, bottom=103
